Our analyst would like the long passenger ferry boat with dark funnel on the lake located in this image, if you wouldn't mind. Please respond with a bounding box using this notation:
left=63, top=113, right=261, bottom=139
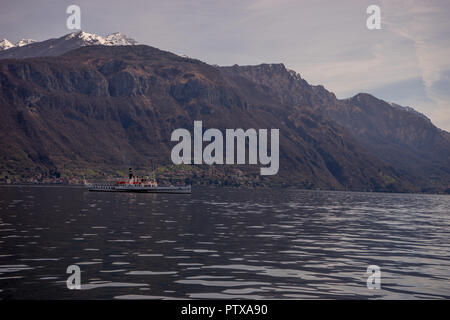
left=85, top=168, right=191, bottom=193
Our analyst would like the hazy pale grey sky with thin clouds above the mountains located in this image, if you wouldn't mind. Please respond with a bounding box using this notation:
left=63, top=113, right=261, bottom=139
left=0, top=0, right=450, bottom=130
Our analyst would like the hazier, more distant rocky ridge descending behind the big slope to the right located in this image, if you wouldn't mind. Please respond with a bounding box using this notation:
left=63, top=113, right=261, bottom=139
left=221, top=64, right=450, bottom=190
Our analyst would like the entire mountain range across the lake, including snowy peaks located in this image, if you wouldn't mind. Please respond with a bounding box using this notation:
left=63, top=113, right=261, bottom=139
left=0, top=33, right=450, bottom=193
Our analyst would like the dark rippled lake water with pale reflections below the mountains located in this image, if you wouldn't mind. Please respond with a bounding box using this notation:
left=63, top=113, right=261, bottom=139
left=0, top=186, right=450, bottom=299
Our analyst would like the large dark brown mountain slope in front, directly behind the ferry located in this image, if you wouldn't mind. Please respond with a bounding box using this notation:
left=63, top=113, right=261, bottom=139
left=0, top=46, right=417, bottom=191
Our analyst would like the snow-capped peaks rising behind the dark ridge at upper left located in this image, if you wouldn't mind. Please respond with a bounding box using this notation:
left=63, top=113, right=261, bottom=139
left=0, top=31, right=137, bottom=59
